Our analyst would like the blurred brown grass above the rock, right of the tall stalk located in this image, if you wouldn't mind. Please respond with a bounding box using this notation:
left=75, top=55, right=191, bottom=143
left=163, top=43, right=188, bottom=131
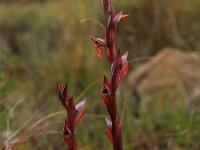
left=118, top=0, right=200, bottom=58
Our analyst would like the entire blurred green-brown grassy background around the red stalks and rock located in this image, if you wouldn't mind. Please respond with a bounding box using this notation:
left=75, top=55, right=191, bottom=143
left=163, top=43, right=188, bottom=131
left=0, top=0, right=200, bottom=150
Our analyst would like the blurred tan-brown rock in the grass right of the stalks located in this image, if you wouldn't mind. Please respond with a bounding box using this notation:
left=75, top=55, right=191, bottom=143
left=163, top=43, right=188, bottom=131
left=128, top=48, right=200, bottom=94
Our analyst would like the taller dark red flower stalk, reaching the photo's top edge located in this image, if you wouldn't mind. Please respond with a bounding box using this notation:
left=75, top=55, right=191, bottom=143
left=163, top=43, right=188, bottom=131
left=90, top=0, right=129, bottom=150
